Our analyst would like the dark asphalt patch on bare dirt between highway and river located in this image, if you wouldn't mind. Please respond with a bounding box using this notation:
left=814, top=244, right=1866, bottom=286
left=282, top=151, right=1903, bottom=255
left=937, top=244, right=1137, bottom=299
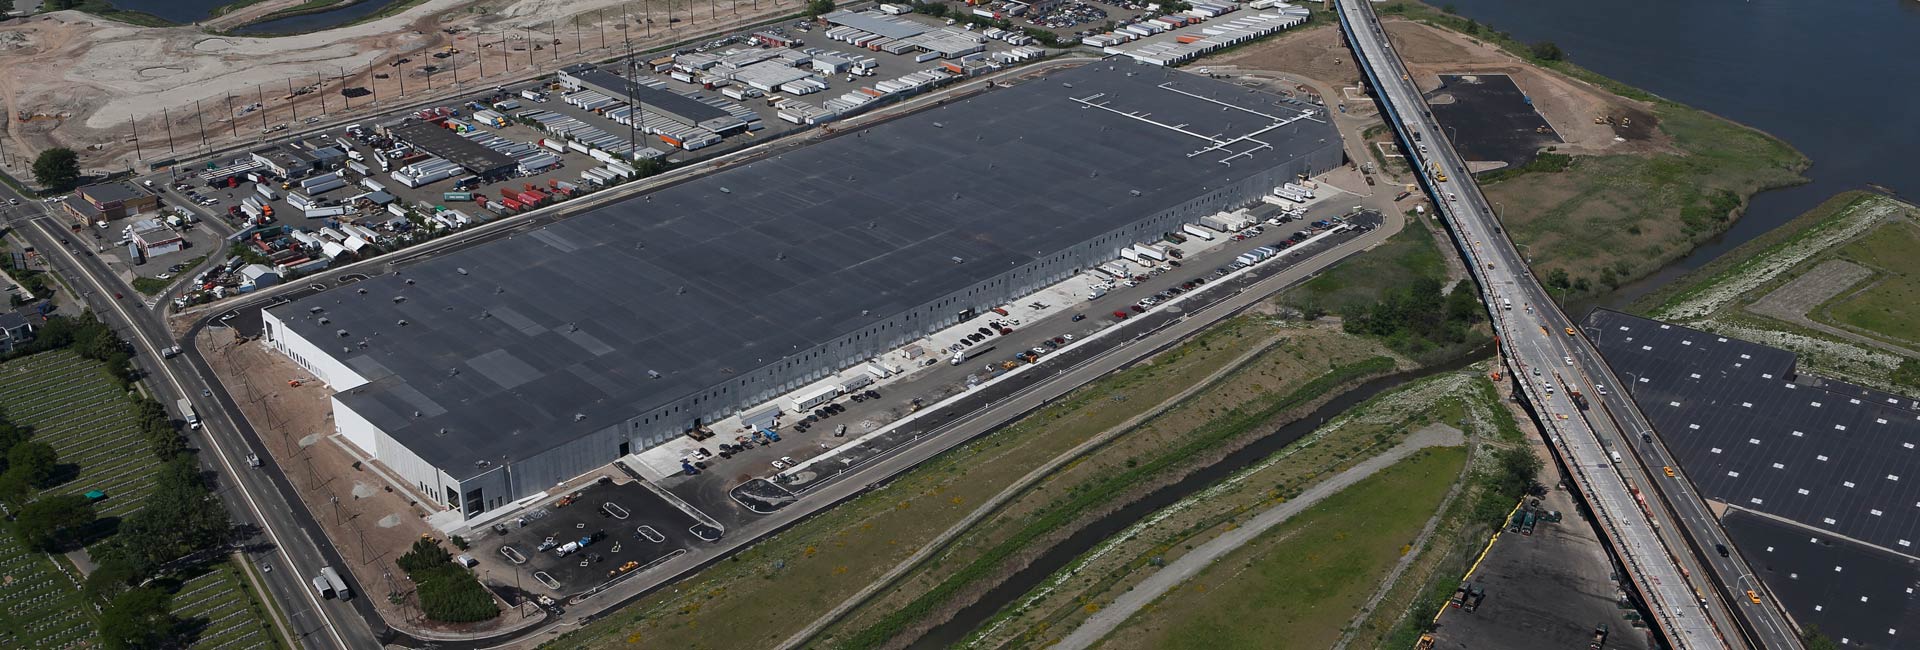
left=1427, top=75, right=1563, bottom=167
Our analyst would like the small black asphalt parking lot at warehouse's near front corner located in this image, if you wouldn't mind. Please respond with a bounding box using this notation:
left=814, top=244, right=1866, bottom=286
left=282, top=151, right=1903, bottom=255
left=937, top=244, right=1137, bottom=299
left=468, top=477, right=718, bottom=598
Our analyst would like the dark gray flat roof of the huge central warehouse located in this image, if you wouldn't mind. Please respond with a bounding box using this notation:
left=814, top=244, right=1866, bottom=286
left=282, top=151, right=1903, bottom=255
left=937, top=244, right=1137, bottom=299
left=275, top=61, right=1340, bottom=477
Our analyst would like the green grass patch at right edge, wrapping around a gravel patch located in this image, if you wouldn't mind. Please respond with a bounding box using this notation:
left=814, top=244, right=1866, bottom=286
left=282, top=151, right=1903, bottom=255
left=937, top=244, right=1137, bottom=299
left=1809, top=221, right=1920, bottom=347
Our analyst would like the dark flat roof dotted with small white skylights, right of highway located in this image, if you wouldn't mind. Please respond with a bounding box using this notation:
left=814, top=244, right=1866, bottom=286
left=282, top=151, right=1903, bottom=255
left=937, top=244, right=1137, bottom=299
left=1586, top=311, right=1920, bottom=556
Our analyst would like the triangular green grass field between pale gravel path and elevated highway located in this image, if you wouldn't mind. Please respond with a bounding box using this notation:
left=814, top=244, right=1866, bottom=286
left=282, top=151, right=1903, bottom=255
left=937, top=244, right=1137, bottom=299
left=1102, top=447, right=1467, bottom=650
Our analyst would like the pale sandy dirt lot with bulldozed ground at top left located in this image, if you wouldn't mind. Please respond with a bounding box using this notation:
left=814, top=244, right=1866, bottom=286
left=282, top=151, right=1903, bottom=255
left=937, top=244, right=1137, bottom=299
left=0, top=0, right=799, bottom=174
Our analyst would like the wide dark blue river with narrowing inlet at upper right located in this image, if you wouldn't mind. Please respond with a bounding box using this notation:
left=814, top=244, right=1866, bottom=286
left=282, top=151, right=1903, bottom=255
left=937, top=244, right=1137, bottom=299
left=1434, top=0, right=1920, bottom=303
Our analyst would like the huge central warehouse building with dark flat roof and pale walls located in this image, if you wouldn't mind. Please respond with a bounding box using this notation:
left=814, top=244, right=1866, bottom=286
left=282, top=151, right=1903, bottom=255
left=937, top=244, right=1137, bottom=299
left=265, top=61, right=1344, bottom=518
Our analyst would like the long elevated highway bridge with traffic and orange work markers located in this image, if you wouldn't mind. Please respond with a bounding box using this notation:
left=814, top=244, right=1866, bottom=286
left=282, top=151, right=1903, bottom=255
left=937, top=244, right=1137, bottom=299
left=1338, top=0, right=1797, bottom=648
